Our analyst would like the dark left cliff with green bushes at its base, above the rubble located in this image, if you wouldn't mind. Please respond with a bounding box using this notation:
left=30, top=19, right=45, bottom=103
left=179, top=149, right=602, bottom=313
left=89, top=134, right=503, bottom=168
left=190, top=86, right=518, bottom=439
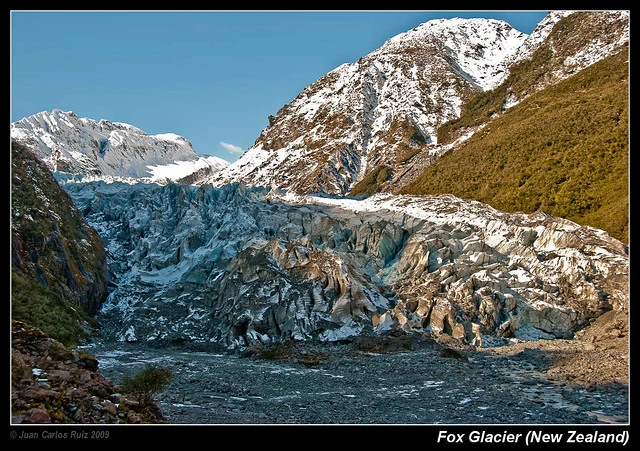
left=11, top=142, right=108, bottom=342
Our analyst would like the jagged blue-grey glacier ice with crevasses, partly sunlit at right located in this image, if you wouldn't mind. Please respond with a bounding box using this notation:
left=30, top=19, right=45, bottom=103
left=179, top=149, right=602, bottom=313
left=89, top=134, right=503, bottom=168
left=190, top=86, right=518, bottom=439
left=65, top=182, right=629, bottom=349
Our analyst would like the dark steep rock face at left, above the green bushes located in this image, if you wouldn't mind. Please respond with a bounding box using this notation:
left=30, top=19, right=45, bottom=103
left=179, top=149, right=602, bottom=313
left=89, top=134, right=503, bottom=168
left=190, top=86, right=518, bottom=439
left=11, top=142, right=107, bottom=315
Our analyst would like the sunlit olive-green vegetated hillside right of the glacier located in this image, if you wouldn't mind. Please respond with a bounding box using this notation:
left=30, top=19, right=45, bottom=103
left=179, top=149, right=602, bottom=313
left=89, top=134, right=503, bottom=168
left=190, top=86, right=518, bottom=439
left=400, top=49, right=629, bottom=243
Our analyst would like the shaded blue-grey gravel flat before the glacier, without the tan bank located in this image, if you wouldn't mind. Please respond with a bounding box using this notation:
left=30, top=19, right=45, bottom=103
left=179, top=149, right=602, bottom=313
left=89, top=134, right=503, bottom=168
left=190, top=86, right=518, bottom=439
left=86, top=343, right=629, bottom=425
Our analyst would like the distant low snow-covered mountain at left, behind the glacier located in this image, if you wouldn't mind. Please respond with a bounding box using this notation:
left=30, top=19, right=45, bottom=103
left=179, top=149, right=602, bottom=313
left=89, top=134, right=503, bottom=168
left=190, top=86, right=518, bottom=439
left=11, top=109, right=228, bottom=183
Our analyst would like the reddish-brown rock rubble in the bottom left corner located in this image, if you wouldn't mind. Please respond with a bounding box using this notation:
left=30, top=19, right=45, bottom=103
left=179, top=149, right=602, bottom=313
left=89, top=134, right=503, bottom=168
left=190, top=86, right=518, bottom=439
left=11, top=321, right=166, bottom=424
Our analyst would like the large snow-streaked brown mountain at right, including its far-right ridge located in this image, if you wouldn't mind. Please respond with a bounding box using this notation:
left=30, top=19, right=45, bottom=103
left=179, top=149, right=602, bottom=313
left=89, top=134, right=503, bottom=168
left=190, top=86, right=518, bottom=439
left=211, top=11, right=629, bottom=195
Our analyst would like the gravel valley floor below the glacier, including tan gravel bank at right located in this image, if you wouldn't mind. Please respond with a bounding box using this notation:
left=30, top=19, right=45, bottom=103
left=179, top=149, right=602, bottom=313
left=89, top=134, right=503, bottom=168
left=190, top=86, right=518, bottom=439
left=87, top=311, right=629, bottom=424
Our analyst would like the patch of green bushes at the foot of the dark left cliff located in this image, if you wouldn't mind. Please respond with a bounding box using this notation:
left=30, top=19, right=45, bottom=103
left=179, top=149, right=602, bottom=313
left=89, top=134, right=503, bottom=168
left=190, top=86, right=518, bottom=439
left=11, top=270, right=96, bottom=346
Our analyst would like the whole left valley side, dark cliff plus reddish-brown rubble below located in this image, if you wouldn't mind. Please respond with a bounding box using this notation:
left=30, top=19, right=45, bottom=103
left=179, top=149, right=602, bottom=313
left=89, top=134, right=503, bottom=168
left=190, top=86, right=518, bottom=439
left=10, top=146, right=166, bottom=424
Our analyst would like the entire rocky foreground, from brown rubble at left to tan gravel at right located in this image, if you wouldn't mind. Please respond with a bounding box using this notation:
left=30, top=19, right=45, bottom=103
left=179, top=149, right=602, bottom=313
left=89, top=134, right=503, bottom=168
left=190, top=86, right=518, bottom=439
left=12, top=311, right=629, bottom=425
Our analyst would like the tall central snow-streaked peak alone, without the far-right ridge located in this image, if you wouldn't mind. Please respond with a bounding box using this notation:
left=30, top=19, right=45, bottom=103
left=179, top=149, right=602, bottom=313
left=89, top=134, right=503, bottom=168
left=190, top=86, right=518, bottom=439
left=212, top=19, right=526, bottom=194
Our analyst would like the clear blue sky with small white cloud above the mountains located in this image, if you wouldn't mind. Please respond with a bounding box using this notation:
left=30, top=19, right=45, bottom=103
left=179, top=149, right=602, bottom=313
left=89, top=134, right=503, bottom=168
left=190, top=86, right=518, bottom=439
left=11, top=10, right=546, bottom=162
